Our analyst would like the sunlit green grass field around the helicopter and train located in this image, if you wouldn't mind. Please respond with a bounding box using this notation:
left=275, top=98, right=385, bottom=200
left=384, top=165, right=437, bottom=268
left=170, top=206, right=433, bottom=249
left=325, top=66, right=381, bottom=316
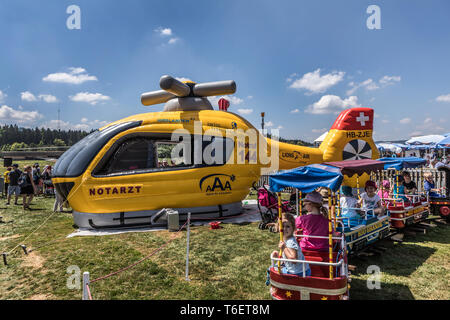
left=0, top=197, right=450, bottom=300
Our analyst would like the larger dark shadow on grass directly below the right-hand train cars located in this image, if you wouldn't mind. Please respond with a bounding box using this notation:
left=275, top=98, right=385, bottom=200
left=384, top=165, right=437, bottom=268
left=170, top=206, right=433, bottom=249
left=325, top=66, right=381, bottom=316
left=350, top=243, right=436, bottom=277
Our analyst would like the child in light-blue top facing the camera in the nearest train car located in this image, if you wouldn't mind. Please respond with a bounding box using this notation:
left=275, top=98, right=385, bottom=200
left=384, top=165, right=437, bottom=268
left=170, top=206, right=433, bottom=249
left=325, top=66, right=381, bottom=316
left=272, top=213, right=311, bottom=277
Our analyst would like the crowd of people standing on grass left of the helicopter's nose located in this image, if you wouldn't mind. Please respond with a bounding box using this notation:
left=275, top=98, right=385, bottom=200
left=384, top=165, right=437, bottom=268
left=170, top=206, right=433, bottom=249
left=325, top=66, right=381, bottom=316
left=3, top=163, right=63, bottom=212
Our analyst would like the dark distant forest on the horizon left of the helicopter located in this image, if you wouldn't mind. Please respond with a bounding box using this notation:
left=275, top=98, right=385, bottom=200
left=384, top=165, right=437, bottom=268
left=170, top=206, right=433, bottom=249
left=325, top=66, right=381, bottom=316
left=0, top=125, right=89, bottom=151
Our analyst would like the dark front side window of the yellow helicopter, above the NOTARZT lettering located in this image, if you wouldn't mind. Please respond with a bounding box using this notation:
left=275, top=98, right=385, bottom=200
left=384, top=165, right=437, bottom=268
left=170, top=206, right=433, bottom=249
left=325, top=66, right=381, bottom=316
left=98, top=138, right=155, bottom=175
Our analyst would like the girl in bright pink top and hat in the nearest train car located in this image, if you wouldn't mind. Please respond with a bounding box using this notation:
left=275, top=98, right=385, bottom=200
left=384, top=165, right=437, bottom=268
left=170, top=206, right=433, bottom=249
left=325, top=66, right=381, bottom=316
left=295, top=192, right=328, bottom=251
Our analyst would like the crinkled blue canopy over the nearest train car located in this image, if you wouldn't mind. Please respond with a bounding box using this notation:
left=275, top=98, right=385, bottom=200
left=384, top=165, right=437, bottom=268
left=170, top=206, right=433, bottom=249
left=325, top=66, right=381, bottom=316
left=269, top=164, right=344, bottom=193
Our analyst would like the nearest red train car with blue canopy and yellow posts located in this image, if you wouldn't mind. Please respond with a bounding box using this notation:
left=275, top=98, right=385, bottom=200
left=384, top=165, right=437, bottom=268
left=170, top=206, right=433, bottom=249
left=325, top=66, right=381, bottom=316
left=268, top=165, right=349, bottom=300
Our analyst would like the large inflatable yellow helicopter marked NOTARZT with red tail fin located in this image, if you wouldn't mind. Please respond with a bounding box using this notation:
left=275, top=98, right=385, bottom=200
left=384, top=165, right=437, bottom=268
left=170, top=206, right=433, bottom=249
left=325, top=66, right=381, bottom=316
left=53, top=76, right=378, bottom=229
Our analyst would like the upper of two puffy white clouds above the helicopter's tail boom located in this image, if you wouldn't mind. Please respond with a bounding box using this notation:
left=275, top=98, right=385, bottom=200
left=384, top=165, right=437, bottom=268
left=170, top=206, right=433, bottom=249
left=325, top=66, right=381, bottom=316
left=289, top=69, right=345, bottom=93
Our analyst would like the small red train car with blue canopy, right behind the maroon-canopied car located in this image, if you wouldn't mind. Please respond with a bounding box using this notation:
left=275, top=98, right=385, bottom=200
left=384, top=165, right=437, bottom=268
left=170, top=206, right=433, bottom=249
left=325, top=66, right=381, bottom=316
left=379, top=157, right=430, bottom=229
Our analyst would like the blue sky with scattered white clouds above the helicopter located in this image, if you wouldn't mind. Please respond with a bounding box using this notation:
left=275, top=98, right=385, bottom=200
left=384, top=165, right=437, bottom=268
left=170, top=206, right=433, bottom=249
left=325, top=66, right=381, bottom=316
left=0, top=0, right=450, bottom=141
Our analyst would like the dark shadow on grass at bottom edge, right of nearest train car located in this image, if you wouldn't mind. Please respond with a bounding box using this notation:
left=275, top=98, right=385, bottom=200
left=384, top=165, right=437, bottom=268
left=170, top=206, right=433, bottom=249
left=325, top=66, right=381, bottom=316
left=350, top=279, right=415, bottom=300
